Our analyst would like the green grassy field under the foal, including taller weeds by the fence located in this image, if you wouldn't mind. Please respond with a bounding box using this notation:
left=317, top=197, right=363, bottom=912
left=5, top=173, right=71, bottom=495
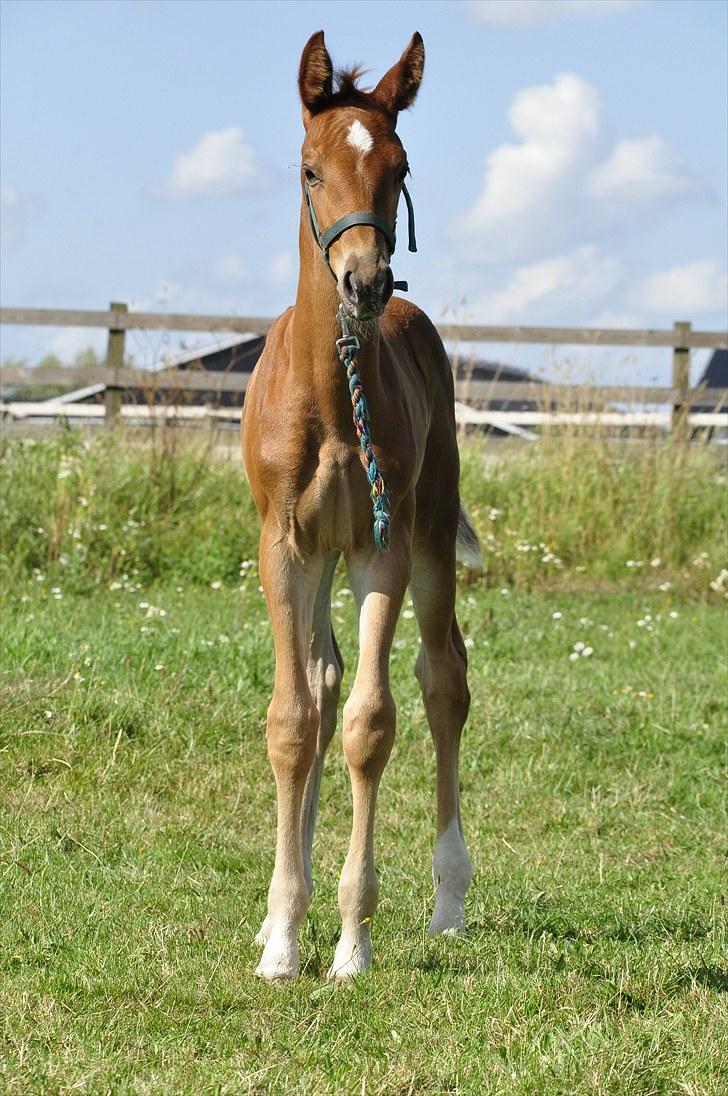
left=0, top=437, right=728, bottom=1096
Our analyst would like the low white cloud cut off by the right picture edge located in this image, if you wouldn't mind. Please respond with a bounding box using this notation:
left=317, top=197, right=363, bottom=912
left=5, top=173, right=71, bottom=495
left=632, top=259, right=728, bottom=318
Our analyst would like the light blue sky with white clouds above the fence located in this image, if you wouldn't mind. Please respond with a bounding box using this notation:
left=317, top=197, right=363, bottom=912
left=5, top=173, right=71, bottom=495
left=0, top=0, right=728, bottom=379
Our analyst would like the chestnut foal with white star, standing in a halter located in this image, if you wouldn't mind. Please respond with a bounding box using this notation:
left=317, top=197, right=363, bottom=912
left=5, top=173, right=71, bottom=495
left=242, top=32, right=479, bottom=979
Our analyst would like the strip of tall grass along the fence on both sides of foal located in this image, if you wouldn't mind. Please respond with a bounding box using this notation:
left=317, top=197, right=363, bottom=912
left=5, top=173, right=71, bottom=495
left=0, top=429, right=727, bottom=594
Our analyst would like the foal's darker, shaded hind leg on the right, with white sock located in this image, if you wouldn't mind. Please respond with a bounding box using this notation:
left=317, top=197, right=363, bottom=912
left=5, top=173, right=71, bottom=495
left=410, top=545, right=473, bottom=935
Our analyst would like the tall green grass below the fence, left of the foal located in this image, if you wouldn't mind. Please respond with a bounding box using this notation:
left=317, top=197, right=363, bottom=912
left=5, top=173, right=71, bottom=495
left=0, top=430, right=258, bottom=589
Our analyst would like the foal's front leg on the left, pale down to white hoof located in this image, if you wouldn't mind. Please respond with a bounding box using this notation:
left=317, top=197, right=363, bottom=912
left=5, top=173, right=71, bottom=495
left=255, top=523, right=322, bottom=980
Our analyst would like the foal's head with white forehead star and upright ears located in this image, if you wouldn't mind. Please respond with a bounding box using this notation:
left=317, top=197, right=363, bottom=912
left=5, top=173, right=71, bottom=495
left=298, top=31, right=424, bottom=320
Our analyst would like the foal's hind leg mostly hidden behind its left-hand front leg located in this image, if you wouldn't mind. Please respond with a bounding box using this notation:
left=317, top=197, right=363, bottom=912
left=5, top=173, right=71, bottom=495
left=255, top=552, right=343, bottom=947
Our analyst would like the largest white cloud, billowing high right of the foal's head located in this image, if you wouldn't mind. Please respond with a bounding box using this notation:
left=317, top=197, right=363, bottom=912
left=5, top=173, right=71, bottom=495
left=452, top=72, right=699, bottom=262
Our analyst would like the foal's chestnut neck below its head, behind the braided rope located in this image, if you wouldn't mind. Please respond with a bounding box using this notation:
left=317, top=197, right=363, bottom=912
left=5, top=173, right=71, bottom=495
left=291, top=215, right=379, bottom=433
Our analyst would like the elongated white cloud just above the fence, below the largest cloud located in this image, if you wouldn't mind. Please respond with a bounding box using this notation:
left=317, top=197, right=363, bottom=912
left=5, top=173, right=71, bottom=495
left=475, top=247, right=622, bottom=323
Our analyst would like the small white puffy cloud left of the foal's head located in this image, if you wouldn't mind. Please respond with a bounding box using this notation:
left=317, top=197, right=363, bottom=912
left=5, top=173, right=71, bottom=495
left=161, top=126, right=261, bottom=198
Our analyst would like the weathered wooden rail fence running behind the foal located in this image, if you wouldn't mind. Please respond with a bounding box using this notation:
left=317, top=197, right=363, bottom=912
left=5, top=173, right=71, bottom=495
left=0, top=301, right=728, bottom=438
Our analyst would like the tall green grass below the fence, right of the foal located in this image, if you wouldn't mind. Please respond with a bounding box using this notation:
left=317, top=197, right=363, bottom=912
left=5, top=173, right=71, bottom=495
left=462, top=434, right=728, bottom=593
